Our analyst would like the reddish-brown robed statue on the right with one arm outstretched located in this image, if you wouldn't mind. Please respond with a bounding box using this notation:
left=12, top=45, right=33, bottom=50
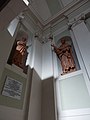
left=51, top=38, right=76, bottom=75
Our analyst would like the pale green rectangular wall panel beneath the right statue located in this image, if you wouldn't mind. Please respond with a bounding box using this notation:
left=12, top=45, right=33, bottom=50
left=59, top=74, right=90, bottom=110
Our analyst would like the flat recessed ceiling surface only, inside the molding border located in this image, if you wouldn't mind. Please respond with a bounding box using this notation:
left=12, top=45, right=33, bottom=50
left=30, top=0, right=75, bottom=21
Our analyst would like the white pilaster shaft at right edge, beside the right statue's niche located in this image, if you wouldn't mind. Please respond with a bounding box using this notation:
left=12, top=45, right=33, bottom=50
left=72, top=22, right=90, bottom=77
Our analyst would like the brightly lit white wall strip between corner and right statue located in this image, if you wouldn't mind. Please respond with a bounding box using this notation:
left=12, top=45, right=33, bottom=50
left=42, top=42, right=54, bottom=79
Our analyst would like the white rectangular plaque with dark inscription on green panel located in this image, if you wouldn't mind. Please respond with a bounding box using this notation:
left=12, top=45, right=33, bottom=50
left=2, top=76, right=23, bottom=100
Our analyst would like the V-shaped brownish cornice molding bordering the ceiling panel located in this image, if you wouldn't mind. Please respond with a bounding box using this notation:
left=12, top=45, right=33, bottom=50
left=29, top=0, right=89, bottom=27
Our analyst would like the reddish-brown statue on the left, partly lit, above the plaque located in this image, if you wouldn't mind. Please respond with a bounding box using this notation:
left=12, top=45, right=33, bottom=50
left=12, top=37, right=27, bottom=68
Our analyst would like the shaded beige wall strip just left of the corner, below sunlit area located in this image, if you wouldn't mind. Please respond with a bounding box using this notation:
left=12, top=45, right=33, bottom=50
left=28, top=70, right=42, bottom=120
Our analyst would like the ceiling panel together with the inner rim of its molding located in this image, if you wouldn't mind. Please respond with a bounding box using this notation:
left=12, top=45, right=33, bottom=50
left=29, top=0, right=81, bottom=23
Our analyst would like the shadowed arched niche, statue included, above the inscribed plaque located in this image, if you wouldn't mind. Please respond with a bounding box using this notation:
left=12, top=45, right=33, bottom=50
left=7, top=30, right=28, bottom=72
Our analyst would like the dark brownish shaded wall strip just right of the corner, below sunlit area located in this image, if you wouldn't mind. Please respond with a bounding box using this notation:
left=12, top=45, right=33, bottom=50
left=41, top=78, right=56, bottom=120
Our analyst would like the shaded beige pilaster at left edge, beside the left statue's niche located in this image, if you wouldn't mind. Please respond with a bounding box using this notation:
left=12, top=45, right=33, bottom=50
left=0, top=29, right=14, bottom=78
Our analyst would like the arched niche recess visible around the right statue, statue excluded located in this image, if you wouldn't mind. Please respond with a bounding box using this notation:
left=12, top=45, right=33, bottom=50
left=56, top=36, right=80, bottom=74
